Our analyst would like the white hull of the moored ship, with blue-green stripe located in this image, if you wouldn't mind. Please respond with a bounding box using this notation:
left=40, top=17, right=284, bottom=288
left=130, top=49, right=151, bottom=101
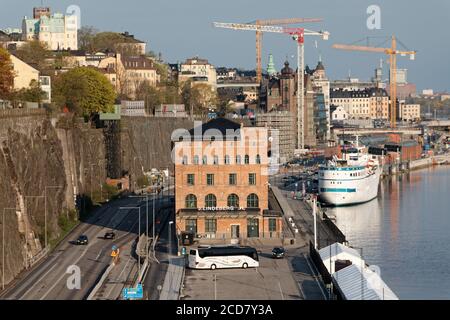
left=319, top=168, right=381, bottom=206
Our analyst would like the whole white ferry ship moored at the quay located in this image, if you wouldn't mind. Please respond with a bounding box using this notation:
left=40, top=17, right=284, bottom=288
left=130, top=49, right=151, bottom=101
left=318, top=148, right=382, bottom=206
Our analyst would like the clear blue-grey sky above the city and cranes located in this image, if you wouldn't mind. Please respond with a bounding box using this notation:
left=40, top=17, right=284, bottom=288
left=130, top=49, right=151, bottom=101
left=0, top=0, right=450, bottom=91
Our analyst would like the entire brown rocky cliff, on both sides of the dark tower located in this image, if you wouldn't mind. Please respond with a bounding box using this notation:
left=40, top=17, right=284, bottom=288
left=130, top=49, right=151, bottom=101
left=0, top=110, right=193, bottom=283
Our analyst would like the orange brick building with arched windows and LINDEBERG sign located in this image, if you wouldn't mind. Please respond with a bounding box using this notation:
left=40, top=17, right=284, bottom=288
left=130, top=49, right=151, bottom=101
left=173, top=118, right=282, bottom=240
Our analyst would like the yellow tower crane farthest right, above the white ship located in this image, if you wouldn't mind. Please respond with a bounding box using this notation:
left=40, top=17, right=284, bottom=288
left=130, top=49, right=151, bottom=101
left=333, top=36, right=417, bottom=128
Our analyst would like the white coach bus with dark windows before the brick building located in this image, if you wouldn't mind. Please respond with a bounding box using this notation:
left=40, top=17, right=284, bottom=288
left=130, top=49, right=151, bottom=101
left=189, top=246, right=259, bottom=270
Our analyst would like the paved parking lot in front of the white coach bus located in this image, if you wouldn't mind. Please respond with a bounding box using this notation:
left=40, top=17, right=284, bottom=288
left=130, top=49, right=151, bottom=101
left=181, top=250, right=302, bottom=300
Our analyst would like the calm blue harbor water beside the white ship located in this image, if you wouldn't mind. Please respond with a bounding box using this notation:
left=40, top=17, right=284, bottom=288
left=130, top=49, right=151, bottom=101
left=328, top=166, right=450, bottom=299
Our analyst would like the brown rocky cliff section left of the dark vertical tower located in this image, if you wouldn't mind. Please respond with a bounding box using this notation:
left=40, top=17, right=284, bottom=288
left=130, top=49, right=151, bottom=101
left=0, top=115, right=106, bottom=283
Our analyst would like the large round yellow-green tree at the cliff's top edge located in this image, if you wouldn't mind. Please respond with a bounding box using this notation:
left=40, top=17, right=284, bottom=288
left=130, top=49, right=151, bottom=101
left=53, top=67, right=116, bottom=118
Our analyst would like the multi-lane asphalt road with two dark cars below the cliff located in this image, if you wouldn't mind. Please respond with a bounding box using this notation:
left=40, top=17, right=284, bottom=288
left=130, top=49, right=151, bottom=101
left=1, top=192, right=171, bottom=300
